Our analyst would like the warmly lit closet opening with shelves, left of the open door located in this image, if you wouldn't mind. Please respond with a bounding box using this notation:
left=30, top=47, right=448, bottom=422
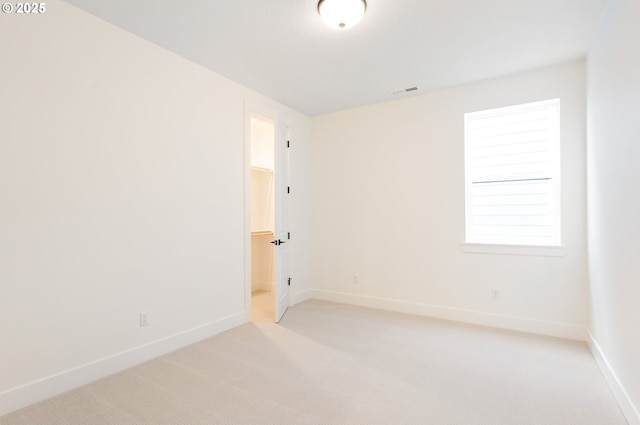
left=249, top=114, right=276, bottom=322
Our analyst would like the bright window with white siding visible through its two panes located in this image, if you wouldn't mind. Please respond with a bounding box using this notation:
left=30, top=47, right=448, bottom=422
left=464, top=99, right=560, bottom=246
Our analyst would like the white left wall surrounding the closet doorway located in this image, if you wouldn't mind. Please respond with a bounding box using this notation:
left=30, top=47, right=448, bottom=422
left=0, top=0, right=309, bottom=414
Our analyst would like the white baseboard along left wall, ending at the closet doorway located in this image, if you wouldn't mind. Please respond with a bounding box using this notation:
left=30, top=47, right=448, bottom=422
left=0, top=312, right=245, bottom=416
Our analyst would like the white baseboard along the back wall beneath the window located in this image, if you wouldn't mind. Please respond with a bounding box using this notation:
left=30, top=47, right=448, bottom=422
left=305, top=289, right=587, bottom=341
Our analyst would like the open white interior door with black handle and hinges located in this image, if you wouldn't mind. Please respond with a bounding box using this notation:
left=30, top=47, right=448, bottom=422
left=273, top=123, right=290, bottom=322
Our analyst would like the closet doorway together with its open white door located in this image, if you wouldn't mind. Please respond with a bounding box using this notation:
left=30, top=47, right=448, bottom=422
left=245, top=104, right=291, bottom=323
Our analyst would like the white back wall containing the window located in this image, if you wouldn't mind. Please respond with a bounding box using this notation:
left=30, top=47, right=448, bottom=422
left=311, top=61, right=588, bottom=339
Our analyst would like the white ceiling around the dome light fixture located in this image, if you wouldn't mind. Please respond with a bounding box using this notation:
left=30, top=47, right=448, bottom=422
left=66, top=0, right=608, bottom=116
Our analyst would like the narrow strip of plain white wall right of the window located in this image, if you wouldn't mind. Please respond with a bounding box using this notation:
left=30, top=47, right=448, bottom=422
left=587, top=0, right=640, bottom=424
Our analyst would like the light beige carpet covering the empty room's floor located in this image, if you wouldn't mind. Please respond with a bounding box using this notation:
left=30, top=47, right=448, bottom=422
left=0, top=300, right=626, bottom=425
